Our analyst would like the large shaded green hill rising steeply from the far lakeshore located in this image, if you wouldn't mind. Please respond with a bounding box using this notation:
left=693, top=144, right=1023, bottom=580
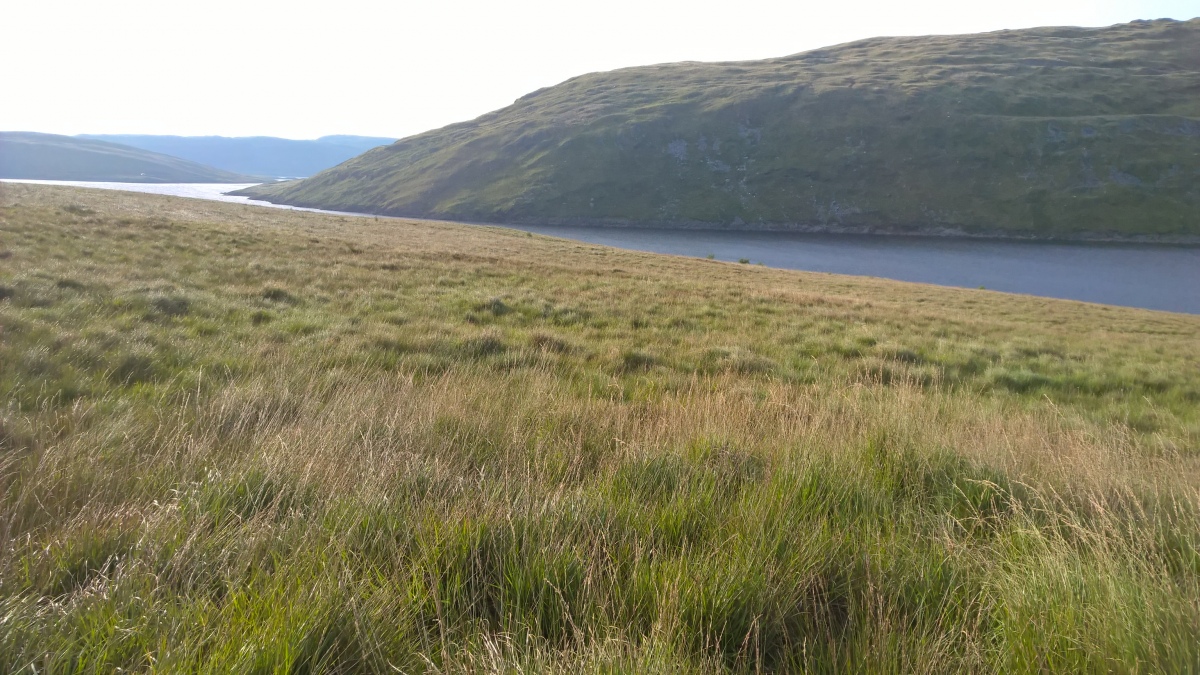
left=238, top=19, right=1200, bottom=239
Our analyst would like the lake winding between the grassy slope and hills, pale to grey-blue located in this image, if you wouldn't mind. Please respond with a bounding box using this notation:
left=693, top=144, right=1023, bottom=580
left=9, top=180, right=1200, bottom=313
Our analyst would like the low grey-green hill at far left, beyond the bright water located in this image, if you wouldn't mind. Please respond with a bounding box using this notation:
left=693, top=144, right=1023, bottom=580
left=0, top=131, right=262, bottom=183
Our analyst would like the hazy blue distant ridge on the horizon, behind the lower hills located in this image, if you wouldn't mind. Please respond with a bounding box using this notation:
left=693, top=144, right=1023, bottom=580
left=79, top=135, right=395, bottom=178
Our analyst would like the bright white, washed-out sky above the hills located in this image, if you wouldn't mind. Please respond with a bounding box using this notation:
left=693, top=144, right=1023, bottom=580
left=0, top=0, right=1200, bottom=138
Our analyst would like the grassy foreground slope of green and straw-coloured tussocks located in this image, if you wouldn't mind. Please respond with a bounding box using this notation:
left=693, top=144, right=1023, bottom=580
left=0, top=185, right=1200, bottom=673
